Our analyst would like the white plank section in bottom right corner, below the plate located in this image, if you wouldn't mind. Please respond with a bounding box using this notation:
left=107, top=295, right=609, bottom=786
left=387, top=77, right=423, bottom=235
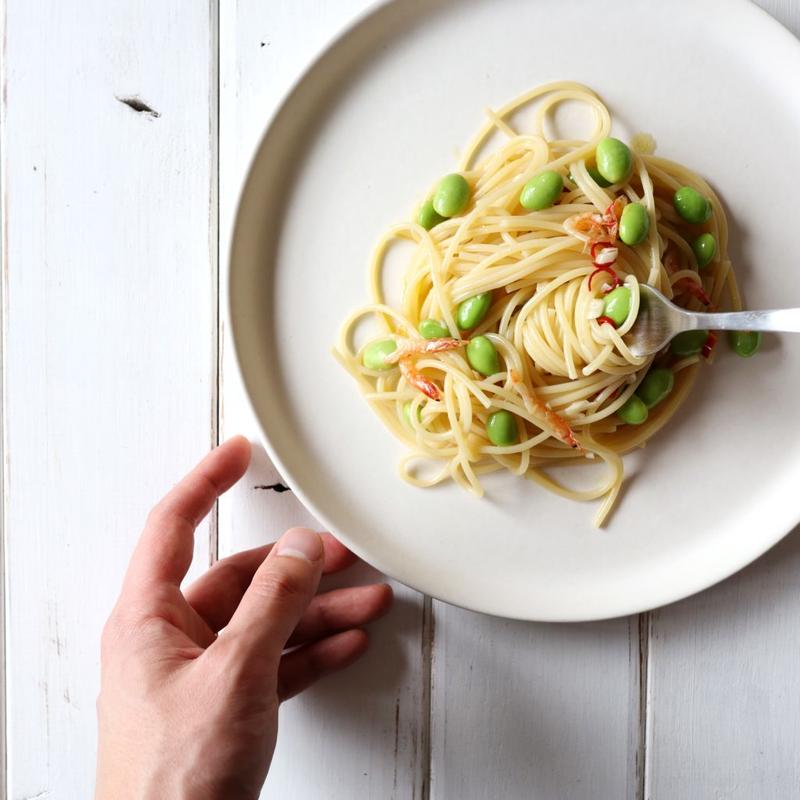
left=645, top=530, right=800, bottom=800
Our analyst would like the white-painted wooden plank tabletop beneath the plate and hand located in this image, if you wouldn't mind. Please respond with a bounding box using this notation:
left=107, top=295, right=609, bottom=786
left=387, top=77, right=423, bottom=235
left=0, top=0, right=800, bottom=800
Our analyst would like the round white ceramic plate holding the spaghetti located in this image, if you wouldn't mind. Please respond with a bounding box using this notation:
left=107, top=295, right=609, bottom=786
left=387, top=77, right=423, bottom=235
left=230, top=0, right=800, bottom=620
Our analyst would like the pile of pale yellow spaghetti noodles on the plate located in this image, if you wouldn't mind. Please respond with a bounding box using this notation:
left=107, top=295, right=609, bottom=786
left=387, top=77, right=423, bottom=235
left=334, top=82, right=741, bottom=526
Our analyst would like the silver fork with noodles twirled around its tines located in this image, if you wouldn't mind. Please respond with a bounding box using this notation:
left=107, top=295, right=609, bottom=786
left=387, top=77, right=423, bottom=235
left=622, top=283, right=800, bottom=356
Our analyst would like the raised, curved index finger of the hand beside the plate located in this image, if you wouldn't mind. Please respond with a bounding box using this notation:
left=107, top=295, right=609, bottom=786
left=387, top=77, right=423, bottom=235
left=123, top=436, right=250, bottom=590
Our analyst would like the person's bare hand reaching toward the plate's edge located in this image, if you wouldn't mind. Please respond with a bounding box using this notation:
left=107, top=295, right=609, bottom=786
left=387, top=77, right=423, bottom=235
left=95, top=437, right=392, bottom=800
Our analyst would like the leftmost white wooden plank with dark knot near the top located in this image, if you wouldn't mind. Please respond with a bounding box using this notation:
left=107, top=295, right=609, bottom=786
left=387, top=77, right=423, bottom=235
left=2, top=0, right=216, bottom=800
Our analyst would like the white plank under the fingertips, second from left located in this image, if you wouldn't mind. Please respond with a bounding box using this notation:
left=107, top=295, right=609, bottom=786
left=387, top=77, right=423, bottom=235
left=219, top=0, right=427, bottom=800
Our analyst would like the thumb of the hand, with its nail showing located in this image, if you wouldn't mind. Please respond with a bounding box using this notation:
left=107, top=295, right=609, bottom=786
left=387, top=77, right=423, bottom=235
left=220, top=528, right=325, bottom=670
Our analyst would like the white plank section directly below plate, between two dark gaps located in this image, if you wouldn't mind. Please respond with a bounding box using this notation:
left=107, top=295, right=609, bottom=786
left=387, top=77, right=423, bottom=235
left=431, top=603, right=639, bottom=800
